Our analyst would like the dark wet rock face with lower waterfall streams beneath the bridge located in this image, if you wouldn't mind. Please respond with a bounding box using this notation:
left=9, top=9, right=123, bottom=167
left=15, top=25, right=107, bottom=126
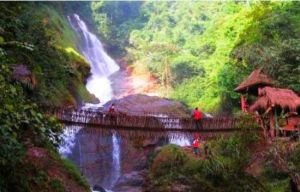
left=59, top=125, right=190, bottom=192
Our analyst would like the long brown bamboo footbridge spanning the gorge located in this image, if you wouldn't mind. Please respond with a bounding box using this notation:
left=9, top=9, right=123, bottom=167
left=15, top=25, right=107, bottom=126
left=55, top=110, right=253, bottom=137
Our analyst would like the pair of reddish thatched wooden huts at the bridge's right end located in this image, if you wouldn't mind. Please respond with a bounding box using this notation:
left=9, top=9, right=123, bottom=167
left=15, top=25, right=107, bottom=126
left=235, top=69, right=300, bottom=138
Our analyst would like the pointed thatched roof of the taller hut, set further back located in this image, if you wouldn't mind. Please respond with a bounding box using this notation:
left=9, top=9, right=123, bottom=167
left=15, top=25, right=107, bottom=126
left=234, top=68, right=273, bottom=92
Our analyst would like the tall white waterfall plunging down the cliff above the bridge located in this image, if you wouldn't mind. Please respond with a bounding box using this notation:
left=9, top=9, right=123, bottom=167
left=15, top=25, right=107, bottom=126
left=68, top=14, right=120, bottom=104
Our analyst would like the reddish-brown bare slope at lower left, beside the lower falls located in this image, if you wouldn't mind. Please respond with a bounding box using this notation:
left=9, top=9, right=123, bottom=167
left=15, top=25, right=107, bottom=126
left=23, top=147, right=89, bottom=192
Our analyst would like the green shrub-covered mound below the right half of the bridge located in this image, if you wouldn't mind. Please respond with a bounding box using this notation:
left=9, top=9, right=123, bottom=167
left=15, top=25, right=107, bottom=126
left=149, top=132, right=265, bottom=192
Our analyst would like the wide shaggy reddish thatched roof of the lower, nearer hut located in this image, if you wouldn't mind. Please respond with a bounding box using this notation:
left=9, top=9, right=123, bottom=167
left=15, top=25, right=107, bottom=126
left=250, top=87, right=300, bottom=111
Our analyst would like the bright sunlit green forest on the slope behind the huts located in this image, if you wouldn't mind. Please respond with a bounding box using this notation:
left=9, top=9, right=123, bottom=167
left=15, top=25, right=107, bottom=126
left=92, top=1, right=300, bottom=112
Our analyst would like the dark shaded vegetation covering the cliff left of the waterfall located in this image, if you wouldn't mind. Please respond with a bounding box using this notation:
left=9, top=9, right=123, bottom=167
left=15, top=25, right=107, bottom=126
left=0, top=2, right=89, bottom=192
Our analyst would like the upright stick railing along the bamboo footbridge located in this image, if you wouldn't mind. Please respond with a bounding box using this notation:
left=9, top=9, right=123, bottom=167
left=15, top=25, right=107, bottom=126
left=55, top=110, right=253, bottom=131
